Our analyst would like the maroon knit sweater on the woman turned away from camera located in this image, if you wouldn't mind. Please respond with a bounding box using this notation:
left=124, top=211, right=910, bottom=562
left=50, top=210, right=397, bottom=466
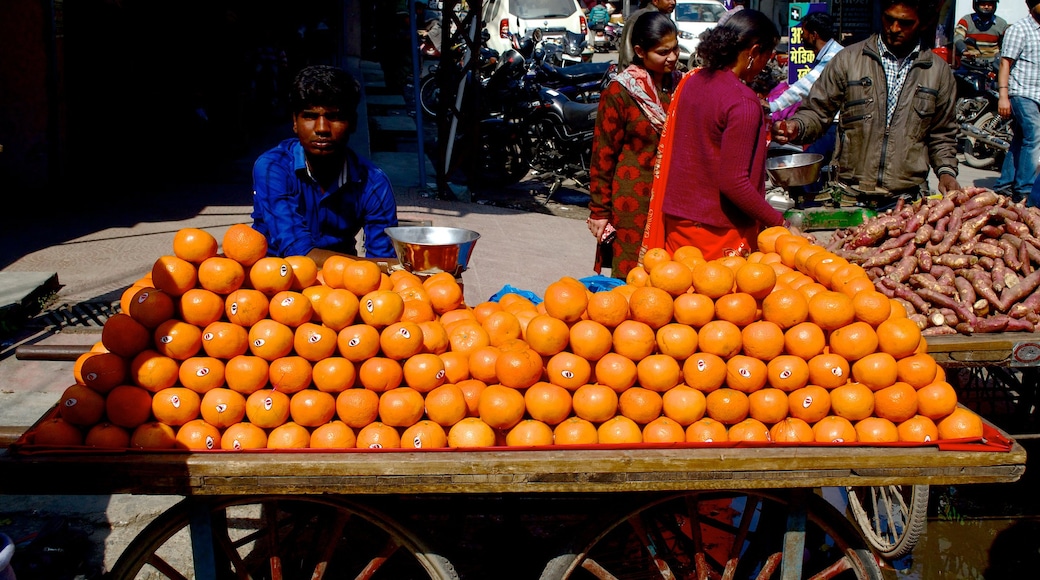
left=664, top=70, right=783, bottom=228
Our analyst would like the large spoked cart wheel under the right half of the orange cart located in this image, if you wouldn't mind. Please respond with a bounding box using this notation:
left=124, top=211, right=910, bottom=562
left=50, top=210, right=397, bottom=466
left=541, top=490, right=882, bottom=580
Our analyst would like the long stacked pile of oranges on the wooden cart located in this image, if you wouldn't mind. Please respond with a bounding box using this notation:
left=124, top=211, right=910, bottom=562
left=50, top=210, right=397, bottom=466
left=32, top=225, right=982, bottom=450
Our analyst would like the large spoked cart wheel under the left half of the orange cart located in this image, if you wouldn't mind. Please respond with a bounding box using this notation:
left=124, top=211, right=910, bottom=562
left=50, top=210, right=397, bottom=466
left=108, top=496, right=459, bottom=580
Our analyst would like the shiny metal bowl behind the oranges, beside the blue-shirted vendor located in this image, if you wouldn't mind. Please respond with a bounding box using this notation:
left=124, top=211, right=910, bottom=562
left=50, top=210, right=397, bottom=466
left=384, top=227, right=480, bottom=275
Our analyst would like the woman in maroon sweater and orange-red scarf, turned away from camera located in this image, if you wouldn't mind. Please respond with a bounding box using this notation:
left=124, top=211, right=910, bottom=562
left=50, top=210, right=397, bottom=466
left=655, top=9, right=784, bottom=260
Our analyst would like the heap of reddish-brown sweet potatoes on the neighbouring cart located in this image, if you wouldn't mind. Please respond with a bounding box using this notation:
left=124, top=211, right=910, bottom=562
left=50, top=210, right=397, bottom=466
left=825, top=188, right=1040, bottom=336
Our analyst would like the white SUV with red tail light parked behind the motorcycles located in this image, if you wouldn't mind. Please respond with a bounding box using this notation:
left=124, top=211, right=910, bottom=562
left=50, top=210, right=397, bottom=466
left=483, top=0, right=592, bottom=55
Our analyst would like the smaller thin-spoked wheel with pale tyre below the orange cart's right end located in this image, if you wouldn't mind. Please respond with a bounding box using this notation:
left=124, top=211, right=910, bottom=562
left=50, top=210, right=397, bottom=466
left=846, top=485, right=928, bottom=560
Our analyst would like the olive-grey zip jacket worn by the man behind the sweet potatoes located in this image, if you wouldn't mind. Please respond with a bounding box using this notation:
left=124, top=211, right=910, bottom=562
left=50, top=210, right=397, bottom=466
left=792, top=34, right=958, bottom=191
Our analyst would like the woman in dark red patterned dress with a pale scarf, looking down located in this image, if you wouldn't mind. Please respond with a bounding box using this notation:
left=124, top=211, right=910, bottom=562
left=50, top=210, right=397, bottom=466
left=588, top=12, right=682, bottom=280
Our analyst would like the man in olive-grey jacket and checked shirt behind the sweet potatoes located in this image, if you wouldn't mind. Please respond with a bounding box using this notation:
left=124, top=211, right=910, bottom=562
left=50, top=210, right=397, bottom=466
left=773, top=0, right=960, bottom=207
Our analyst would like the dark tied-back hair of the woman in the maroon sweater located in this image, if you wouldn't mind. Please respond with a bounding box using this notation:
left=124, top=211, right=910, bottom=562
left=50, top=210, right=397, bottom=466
left=697, top=8, right=780, bottom=71
